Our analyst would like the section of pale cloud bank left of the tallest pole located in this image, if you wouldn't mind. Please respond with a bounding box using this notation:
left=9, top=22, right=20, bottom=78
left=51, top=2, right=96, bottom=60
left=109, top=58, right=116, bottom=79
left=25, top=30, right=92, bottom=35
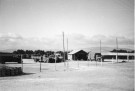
left=0, top=33, right=62, bottom=50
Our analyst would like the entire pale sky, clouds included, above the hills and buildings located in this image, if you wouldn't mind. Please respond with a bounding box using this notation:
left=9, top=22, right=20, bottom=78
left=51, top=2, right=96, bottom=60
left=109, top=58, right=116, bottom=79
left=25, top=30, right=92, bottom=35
left=0, top=0, right=134, bottom=50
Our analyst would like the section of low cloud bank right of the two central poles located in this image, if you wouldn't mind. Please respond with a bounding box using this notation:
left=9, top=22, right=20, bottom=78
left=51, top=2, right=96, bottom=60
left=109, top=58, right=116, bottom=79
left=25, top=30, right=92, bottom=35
left=66, top=34, right=134, bottom=49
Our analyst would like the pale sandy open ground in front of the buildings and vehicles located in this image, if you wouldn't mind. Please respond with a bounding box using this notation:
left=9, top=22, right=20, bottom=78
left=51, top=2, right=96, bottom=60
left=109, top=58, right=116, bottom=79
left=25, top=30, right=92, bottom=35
left=0, top=61, right=134, bottom=91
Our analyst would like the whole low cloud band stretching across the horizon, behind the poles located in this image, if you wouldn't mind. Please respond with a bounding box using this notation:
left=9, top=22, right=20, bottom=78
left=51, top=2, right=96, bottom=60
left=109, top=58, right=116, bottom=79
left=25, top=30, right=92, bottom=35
left=0, top=33, right=134, bottom=50
